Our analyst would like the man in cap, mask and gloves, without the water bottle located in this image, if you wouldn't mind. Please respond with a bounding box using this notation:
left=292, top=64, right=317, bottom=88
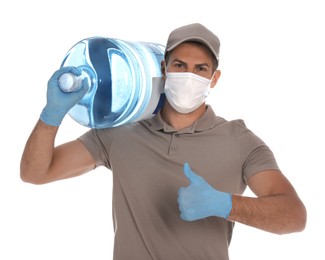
left=21, top=24, right=306, bottom=260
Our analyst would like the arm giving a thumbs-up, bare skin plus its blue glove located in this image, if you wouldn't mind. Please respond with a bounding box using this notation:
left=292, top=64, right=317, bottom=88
left=178, top=163, right=306, bottom=234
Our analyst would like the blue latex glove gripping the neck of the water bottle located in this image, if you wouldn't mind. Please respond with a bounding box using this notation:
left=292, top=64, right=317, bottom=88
left=40, top=67, right=89, bottom=126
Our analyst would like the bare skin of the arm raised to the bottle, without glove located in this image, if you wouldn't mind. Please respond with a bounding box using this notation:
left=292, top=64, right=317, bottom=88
left=20, top=120, right=95, bottom=184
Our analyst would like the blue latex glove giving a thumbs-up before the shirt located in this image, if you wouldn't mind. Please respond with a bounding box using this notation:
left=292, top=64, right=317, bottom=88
left=178, top=163, right=232, bottom=221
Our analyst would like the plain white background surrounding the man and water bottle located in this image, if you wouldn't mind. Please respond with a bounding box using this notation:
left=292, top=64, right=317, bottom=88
left=0, top=0, right=325, bottom=260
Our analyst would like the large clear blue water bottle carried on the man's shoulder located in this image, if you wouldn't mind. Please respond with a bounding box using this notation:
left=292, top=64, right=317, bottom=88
left=61, top=37, right=165, bottom=128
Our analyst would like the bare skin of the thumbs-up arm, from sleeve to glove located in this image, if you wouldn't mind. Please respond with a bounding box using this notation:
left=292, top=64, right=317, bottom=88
left=227, top=170, right=307, bottom=234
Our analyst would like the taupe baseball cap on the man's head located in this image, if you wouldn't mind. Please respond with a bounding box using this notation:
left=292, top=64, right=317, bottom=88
left=165, top=23, right=220, bottom=60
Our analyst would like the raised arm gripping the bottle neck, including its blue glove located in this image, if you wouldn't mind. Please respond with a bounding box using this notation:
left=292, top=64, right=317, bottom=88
left=20, top=67, right=95, bottom=184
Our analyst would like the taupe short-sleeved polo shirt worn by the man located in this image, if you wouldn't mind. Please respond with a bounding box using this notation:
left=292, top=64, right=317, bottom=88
left=80, top=106, right=278, bottom=260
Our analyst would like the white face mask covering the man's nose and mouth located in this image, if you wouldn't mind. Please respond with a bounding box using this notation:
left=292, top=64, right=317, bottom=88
left=165, top=72, right=213, bottom=114
